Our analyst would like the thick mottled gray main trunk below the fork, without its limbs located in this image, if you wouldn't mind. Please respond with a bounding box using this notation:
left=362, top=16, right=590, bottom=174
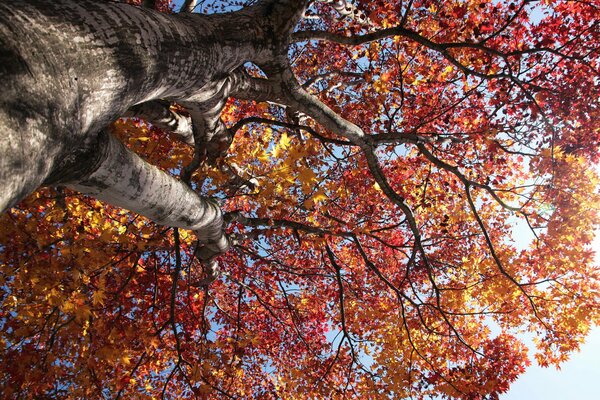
left=0, top=1, right=251, bottom=205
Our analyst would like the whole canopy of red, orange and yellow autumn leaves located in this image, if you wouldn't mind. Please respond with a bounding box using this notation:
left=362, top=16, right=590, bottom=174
left=0, top=0, right=600, bottom=399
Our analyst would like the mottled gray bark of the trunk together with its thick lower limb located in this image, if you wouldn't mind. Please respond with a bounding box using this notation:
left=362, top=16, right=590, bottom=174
left=0, top=0, right=304, bottom=258
